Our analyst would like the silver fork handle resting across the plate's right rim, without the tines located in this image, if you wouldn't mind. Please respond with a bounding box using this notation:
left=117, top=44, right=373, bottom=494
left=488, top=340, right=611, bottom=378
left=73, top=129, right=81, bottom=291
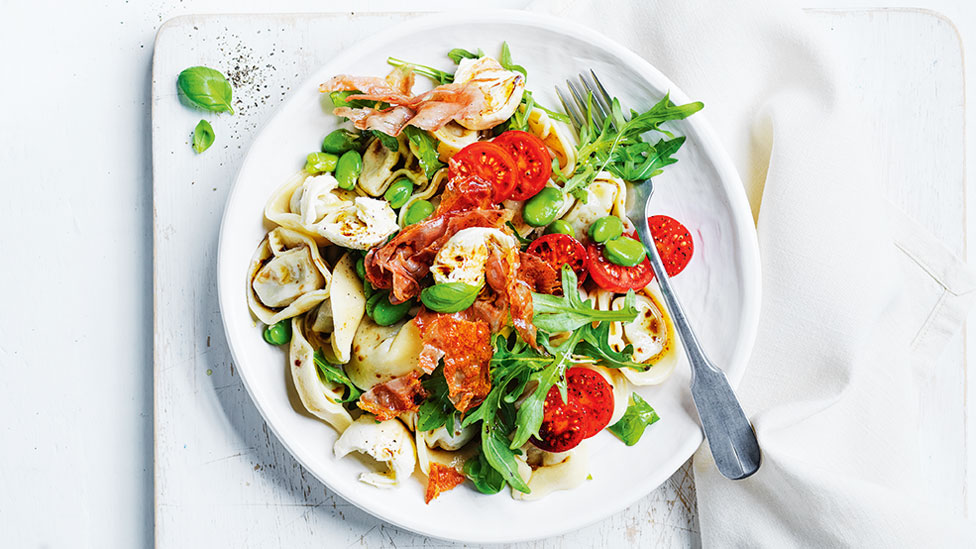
left=636, top=208, right=761, bottom=479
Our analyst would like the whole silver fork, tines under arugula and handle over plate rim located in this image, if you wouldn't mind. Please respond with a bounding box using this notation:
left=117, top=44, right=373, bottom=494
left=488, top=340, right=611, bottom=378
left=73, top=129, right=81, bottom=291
left=556, top=70, right=762, bottom=480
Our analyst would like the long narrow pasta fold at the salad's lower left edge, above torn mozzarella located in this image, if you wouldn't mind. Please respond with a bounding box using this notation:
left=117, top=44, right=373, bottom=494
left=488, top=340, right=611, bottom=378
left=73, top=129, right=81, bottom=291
left=288, top=317, right=352, bottom=433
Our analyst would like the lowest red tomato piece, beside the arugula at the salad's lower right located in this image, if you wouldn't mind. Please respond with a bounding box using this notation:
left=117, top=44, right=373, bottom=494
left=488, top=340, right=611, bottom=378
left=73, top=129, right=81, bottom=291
left=531, top=368, right=613, bottom=452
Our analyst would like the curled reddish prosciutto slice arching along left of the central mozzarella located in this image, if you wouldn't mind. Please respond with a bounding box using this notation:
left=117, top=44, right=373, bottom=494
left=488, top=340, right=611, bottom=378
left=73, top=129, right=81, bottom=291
left=364, top=209, right=511, bottom=303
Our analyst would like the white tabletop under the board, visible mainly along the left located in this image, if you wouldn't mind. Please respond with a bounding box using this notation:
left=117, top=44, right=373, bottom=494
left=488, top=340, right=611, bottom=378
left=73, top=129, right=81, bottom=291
left=0, top=0, right=976, bottom=547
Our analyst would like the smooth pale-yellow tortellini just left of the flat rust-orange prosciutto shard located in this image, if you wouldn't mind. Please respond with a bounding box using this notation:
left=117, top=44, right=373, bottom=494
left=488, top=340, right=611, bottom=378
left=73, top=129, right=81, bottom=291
left=346, top=317, right=423, bottom=389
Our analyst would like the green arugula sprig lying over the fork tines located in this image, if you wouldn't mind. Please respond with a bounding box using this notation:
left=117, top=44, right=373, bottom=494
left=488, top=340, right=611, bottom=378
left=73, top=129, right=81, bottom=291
left=563, top=95, right=704, bottom=197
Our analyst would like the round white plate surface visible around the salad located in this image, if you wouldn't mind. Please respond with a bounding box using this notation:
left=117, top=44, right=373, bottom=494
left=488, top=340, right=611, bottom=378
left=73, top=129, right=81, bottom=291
left=217, top=12, right=760, bottom=542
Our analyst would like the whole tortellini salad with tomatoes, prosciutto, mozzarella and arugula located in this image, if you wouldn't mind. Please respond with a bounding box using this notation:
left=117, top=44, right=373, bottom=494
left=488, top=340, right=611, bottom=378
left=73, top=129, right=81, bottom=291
left=247, top=44, right=702, bottom=503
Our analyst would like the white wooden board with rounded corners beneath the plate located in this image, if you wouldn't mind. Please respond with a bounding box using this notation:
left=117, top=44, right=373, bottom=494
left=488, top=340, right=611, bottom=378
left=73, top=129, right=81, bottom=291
left=152, top=11, right=967, bottom=548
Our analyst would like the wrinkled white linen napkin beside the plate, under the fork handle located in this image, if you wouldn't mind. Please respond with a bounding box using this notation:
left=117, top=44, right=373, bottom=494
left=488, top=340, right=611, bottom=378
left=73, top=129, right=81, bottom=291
left=530, top=0, right=976, bottom=547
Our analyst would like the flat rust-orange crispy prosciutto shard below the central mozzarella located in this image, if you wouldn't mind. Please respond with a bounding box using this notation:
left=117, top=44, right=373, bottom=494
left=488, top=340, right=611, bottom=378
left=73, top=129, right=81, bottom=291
left=414, top=309, right=492, bottom=412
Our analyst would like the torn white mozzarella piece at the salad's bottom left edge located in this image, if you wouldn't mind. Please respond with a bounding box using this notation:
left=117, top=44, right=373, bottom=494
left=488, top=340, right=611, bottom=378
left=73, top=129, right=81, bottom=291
left=333, top=415, right=417, bottom=488
